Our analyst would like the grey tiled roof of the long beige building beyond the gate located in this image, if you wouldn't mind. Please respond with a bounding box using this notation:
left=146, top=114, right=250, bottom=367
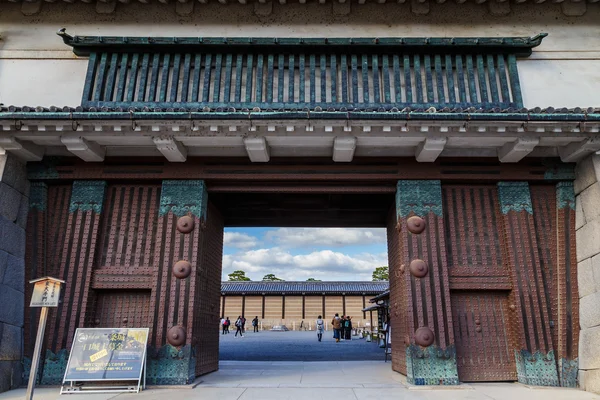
left=221, top=281, right=389, bottom=295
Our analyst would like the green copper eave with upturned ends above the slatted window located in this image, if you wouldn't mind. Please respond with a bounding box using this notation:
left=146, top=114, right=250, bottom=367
left=57, top=28, right=548, bottom=57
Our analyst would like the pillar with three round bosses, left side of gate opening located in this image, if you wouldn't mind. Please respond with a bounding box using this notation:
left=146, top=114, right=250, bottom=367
left=147, top=180, right=223, bottom=384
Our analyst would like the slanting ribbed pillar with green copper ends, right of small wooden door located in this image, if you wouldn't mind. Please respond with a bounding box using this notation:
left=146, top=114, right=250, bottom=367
left=498, top=182, right=564, bottom=386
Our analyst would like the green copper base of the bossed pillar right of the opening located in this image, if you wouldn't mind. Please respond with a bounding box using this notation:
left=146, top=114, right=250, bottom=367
left=406, top=344, right=459, bottom=385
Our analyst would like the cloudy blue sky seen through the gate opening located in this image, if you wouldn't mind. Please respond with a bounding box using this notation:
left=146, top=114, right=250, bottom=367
left=223, top=228, right=388, bottom=281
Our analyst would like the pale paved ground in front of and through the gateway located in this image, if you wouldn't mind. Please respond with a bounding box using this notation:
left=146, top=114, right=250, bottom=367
left=0, top=361, right=600, bottom=400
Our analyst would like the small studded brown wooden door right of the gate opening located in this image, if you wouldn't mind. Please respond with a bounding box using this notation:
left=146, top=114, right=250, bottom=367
left=451, top=291, right=517, bottom=382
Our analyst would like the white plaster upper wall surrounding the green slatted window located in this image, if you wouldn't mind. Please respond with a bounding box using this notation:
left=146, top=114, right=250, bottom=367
left=0, top=2, right=600, bottom=107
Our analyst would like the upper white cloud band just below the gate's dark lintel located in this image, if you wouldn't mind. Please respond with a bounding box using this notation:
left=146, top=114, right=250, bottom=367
left=265, top=228, right=386, bottom=247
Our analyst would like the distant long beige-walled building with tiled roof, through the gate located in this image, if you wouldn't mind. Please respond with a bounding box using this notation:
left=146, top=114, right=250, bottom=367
left=221, top=282, right=389, bottom=330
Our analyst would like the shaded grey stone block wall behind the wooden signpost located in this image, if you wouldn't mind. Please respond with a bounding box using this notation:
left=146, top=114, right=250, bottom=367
left=0, top=154, right=29, bottom=392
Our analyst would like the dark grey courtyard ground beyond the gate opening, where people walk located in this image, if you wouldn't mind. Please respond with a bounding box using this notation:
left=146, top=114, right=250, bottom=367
left=219, top=331, right=384, bottom=361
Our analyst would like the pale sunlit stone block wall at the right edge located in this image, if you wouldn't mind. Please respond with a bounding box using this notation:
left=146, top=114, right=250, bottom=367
left=575, top=155, right=600, bottom=393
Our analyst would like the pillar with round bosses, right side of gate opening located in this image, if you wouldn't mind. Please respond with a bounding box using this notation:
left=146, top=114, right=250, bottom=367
left=388, top=180, right=458, bottom=385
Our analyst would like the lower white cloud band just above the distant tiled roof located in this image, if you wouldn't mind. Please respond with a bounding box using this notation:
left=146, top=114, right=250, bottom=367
left=223, top=247, right=388, bottom=281
